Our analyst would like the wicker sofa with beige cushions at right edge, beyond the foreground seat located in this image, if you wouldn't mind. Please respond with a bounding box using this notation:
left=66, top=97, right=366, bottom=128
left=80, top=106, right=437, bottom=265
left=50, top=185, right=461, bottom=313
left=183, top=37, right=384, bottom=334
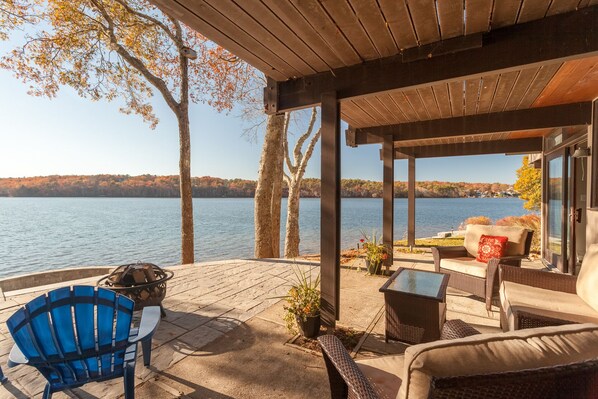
left=500, top=244, right=598, bottom=331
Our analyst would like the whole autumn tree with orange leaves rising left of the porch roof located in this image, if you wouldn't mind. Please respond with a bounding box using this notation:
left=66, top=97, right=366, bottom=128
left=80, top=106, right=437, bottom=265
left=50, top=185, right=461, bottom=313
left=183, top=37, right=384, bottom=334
left=0, top=0, right=250, bottom=264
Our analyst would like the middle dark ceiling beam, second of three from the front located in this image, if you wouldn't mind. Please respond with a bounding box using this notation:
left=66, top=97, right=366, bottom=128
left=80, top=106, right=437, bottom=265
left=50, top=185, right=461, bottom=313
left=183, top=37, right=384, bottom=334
left=345, top=101, right=592, bottom=147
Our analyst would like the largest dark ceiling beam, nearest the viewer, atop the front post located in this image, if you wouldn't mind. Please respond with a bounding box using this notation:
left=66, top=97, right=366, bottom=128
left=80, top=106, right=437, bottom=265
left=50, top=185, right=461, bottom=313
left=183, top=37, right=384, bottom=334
left=264, top=6, right=598, bottom=114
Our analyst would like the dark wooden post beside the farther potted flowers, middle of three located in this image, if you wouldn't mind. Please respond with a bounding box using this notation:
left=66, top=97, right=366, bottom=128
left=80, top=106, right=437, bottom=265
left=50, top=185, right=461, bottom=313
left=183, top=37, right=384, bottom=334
left=382, top=135, right=395, bottom=269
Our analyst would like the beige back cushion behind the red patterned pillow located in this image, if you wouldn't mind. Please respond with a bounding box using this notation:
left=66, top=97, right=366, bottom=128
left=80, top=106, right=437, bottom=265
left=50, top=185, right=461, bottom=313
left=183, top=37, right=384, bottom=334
left=463, top=224, right=527, bottom=257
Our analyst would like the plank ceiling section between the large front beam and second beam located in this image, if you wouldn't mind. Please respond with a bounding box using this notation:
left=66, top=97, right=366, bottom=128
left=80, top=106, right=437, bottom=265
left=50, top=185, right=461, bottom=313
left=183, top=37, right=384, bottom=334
left=342, top=54, right=598, bottom=128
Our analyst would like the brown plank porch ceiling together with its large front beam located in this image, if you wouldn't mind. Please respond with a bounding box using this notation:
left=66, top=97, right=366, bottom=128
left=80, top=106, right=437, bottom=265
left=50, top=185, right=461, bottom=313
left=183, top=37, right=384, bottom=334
left=151, top=0, right=598, bottom=151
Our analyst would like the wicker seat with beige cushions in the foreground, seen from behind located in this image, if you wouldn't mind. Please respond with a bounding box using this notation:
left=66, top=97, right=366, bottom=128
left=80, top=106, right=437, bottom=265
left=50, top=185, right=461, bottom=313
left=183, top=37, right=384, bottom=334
left=319, top=322, right=598, bottom=399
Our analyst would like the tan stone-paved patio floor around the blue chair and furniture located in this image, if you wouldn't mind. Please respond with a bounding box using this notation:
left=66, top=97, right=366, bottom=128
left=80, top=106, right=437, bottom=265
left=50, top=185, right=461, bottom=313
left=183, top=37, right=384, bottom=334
left=0, top=254, right=542, bottom=399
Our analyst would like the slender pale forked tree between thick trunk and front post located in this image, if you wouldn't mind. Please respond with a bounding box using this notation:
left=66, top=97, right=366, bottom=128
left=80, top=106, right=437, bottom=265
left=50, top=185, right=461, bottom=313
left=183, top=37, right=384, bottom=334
left=283, top=107, right=321, bottom=258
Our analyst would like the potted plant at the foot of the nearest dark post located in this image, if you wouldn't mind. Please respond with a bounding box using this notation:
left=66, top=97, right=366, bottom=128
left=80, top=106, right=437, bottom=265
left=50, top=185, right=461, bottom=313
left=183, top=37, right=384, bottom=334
left=284, top=268, right=321, bottom=338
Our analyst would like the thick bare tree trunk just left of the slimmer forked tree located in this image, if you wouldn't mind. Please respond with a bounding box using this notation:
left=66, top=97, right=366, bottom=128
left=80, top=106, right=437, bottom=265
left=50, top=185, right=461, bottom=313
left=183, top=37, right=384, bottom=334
left=254, top=115, right=285, bottom=258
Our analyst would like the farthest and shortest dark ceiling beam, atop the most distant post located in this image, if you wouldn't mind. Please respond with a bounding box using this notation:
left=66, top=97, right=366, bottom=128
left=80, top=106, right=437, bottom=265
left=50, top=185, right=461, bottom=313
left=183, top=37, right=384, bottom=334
left=395, top=137, right=542, bottom=159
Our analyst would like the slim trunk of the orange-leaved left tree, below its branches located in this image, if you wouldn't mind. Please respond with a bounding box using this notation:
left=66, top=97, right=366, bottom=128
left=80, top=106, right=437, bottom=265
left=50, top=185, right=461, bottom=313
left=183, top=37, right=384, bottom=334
left=178, top=107, right=195, bottom=265
